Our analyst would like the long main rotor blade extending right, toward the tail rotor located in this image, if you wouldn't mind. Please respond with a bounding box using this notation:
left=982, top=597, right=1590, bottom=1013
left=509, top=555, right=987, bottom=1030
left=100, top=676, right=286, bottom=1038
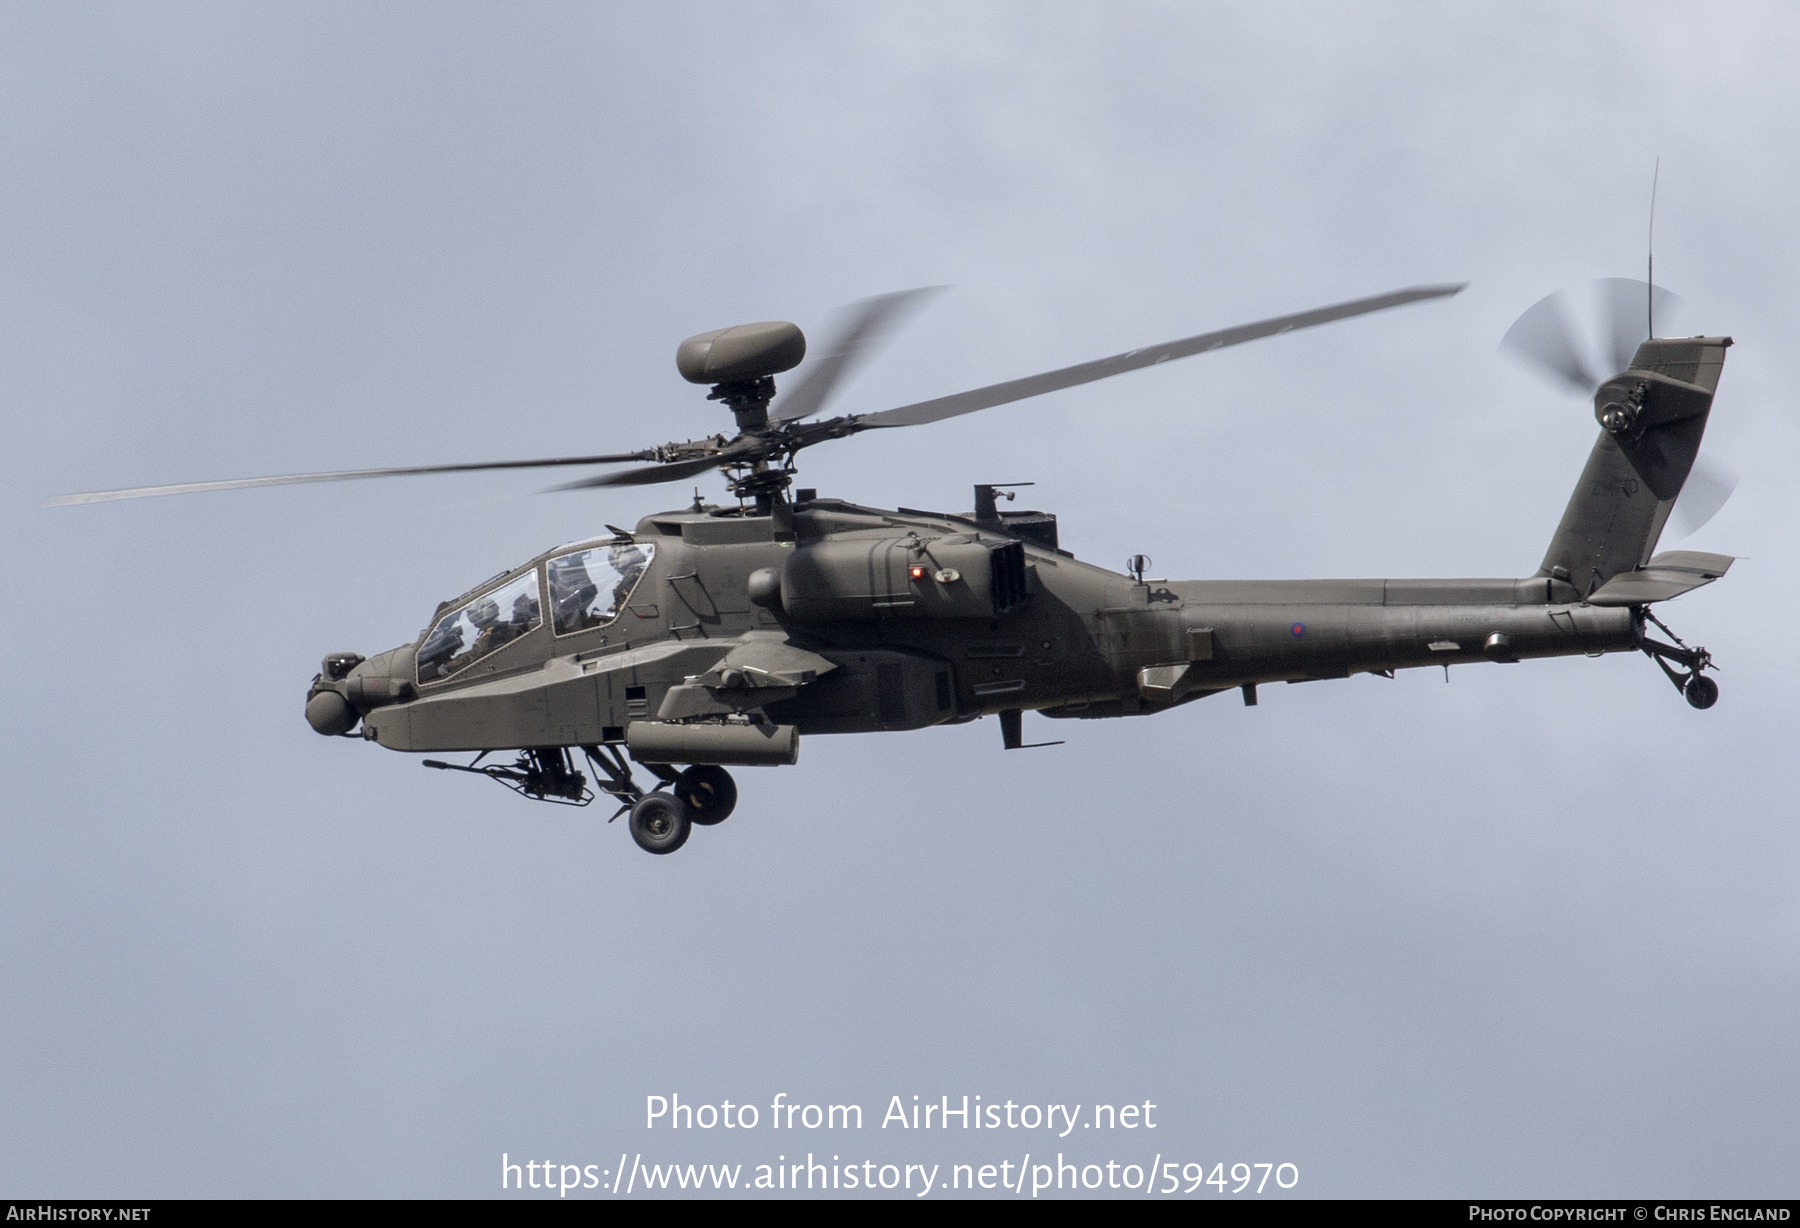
left=857, top=281, right=1469, bottom=429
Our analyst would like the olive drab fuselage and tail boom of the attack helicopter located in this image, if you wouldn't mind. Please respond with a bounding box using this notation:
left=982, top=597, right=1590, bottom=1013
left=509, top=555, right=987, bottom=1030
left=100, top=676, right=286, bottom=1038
left=313, top=492, right=1642, bottom=762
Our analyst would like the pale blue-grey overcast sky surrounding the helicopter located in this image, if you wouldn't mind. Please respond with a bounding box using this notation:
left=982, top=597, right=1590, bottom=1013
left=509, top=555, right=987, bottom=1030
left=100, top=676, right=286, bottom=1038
left=0, top=4, right=1800, bottom=1197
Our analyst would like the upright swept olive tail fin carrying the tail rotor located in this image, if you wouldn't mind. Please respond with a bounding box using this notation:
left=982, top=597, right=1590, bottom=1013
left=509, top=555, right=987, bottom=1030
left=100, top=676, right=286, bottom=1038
left=1537, top=337, right=1732, bottom=598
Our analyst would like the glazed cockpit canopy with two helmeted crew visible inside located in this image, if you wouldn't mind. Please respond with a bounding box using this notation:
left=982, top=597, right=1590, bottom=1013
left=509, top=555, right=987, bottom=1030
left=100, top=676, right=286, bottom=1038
left=418, top=542, right=657, bottom=684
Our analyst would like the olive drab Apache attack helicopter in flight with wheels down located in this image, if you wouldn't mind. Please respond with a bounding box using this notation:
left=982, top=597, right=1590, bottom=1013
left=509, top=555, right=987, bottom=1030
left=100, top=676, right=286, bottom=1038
left=45, top=283, right=1732, bottom=853
